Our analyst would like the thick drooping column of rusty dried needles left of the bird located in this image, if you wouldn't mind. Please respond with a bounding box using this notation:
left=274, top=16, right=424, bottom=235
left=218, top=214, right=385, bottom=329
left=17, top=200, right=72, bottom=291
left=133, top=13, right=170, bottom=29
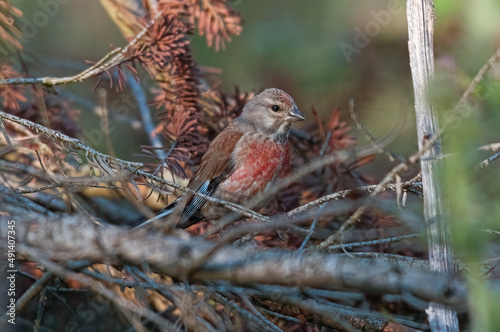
left=125, top=15, right=207, bottom=174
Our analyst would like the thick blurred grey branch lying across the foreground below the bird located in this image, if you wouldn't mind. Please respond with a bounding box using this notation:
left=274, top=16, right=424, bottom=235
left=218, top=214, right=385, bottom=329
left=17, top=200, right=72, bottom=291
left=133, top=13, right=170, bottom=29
left=0, top=215, right=466, bottom=305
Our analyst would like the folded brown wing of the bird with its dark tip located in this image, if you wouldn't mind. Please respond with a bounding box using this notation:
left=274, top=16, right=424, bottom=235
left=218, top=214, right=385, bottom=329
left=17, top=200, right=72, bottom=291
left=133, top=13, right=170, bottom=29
left=176, top=125, right=243, bottom=228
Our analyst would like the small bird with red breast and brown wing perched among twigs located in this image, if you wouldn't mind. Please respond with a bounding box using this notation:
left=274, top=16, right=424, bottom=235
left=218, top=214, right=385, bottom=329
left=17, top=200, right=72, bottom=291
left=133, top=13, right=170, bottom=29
left=139, top=88, right=305, bottom=228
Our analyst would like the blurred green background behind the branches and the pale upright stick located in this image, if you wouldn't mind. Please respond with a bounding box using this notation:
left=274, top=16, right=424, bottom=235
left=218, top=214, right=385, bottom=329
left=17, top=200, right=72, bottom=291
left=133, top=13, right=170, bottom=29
left=8, top=0, right=500, bottom=331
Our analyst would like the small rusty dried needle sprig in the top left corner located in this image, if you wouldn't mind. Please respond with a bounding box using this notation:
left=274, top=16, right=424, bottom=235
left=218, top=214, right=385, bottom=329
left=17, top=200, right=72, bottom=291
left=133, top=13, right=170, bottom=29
left=0, top=0, right=23, bottom=50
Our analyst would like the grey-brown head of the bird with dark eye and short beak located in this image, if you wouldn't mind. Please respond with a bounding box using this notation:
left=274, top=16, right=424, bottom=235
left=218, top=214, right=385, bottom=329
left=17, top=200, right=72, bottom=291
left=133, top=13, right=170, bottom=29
left=241, top=88, right=305, bottom=139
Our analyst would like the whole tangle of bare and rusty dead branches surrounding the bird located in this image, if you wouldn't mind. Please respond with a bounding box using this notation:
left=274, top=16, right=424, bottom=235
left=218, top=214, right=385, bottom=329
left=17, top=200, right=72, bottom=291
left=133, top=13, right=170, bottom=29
left=0, top=0, right=498, bottom=331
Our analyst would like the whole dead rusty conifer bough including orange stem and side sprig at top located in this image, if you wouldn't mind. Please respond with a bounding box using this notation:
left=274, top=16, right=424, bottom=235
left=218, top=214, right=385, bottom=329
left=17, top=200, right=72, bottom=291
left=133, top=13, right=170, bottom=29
left=101, top=0, right=241, bottom=173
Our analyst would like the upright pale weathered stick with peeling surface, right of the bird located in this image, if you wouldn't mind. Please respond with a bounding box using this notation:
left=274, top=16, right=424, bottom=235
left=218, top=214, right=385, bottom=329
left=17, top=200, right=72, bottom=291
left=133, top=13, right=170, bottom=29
left=407, top=0, right=459, bottom=331
